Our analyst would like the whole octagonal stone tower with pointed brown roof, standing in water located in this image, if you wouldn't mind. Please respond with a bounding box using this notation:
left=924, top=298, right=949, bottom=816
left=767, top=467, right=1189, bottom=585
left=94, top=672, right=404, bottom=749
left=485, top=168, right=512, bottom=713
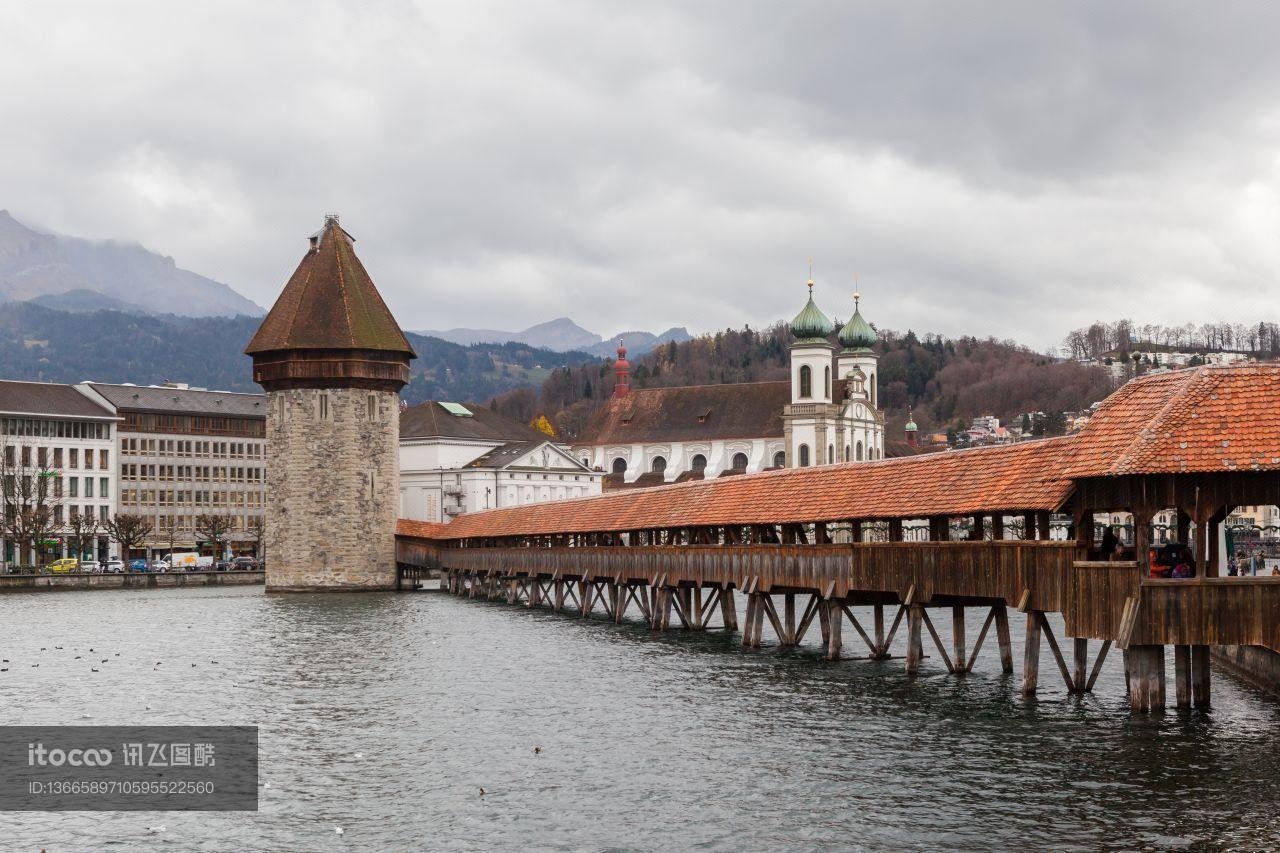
left=244, top=216, right=417, bottom=592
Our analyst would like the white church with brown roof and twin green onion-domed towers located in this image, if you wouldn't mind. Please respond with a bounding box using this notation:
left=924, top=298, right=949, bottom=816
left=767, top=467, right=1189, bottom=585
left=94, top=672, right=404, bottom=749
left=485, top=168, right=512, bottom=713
left=571, top=280, right=884, bottom=488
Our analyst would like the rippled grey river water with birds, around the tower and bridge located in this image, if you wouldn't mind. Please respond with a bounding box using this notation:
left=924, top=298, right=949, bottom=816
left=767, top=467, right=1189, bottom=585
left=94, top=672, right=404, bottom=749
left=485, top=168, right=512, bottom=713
left=0, top=588, right=1280, bottom=853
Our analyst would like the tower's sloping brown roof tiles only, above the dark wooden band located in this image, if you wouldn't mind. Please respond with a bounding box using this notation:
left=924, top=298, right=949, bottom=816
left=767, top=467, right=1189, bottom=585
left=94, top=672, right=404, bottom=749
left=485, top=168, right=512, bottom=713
left=244, top=216, right=417, bottom=357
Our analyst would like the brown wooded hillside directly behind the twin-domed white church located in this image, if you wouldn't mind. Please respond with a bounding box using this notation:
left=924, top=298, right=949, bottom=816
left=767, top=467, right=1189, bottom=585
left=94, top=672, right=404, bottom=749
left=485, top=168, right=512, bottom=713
left=493, top=324, right=1112, bottom=438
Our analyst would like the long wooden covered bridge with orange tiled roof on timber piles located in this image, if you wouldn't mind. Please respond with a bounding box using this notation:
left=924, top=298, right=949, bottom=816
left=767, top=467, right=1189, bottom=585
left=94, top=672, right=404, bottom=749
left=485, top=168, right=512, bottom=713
left=397, top=365, right=1280, bottom=711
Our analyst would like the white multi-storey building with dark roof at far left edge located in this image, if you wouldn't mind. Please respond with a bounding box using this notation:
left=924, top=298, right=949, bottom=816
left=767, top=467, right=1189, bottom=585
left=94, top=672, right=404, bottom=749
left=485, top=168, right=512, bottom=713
left=0, top=380, right=120, bottom=569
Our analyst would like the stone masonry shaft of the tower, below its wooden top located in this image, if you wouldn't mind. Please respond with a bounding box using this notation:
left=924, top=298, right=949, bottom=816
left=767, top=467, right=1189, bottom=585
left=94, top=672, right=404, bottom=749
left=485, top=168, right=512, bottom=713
left=266, top=388, right=399, bottom=592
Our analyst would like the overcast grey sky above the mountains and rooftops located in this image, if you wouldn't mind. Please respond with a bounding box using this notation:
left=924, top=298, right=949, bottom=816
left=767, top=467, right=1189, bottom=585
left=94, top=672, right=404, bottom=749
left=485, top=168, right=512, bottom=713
left=0, top=0, right=1280, bottom=348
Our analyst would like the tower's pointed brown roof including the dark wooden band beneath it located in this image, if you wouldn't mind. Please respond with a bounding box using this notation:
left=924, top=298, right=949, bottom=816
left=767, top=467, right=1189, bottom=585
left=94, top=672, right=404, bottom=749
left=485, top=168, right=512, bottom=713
left=244, top=216, right=417, bottom=391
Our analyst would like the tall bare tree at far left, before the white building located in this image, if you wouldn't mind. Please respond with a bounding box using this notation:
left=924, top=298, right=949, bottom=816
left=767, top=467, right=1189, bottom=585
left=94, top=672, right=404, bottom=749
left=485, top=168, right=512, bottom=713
left=0, top=442, right=61, bottom=566
